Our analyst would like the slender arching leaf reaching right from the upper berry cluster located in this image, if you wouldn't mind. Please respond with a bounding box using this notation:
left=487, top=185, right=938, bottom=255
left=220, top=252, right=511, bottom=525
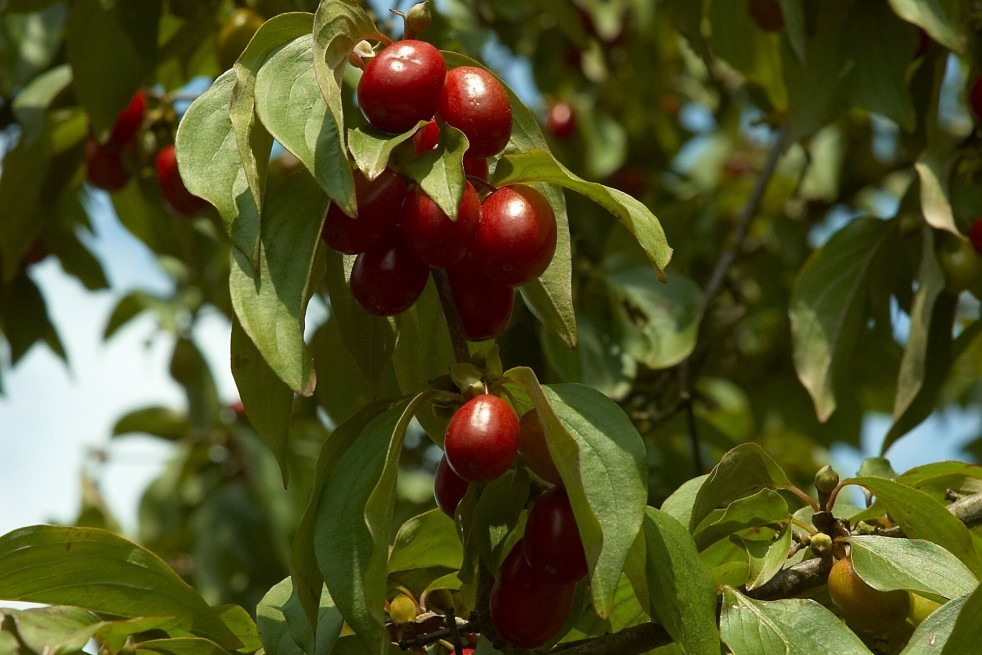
left=491, top=148, right=672, bottom=278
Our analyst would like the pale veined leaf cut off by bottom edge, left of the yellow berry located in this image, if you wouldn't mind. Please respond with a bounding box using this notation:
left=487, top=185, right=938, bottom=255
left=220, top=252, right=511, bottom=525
left=720, top=586, right=870, bottom=655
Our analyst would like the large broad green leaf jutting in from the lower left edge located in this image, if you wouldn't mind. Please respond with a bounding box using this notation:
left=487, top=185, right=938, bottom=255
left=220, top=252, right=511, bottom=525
left=0, top=525, right=240, bottom=648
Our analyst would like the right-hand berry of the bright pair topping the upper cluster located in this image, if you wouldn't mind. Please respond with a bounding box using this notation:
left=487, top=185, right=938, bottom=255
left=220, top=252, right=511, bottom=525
left=439, top=66, right=512, bottom=157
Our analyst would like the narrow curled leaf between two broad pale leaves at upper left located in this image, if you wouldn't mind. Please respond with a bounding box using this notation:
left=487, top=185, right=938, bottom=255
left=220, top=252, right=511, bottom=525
left=229, top=13, right=314, bottom=268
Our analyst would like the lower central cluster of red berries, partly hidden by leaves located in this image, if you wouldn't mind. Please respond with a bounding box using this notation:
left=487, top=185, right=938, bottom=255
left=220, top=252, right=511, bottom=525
left=433, top=394, right=587, bottom=648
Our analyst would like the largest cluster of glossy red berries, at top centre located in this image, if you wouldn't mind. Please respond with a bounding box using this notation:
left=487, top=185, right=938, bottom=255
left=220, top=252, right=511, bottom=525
left=322, top=39, right=556, bottom=340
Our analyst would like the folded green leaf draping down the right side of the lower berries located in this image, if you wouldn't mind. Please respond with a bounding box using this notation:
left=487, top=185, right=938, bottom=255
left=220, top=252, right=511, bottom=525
left=505, top=368, right=647, bottom=618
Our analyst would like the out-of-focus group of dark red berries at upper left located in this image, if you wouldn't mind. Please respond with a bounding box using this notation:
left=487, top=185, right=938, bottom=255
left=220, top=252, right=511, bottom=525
left=85, top=91, right=208, bottom=216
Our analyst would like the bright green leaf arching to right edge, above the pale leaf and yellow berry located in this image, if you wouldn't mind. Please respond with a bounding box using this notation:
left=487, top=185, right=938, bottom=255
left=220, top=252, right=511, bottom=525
left=847, top=477, right=982, bottom=576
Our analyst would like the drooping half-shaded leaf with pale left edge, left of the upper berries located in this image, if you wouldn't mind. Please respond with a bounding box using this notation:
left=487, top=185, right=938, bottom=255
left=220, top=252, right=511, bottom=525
left=229, top=169, right=327, bottom=395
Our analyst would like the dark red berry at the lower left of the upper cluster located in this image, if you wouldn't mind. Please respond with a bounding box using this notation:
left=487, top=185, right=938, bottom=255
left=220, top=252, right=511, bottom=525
left=349, top=238, right=430, bottom=316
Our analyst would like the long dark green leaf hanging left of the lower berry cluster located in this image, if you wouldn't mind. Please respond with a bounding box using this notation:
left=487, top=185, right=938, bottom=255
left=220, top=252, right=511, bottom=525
left=313, top=394, right=425, bottom=654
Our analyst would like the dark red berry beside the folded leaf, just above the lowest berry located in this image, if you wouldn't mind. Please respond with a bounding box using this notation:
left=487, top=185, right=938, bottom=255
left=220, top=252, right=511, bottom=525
left=525, top=488, right=587, bottom=582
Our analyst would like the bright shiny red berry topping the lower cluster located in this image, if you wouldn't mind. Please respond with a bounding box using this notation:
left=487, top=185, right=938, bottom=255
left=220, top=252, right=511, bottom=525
left=443, top=394, right=518, bottom=482
